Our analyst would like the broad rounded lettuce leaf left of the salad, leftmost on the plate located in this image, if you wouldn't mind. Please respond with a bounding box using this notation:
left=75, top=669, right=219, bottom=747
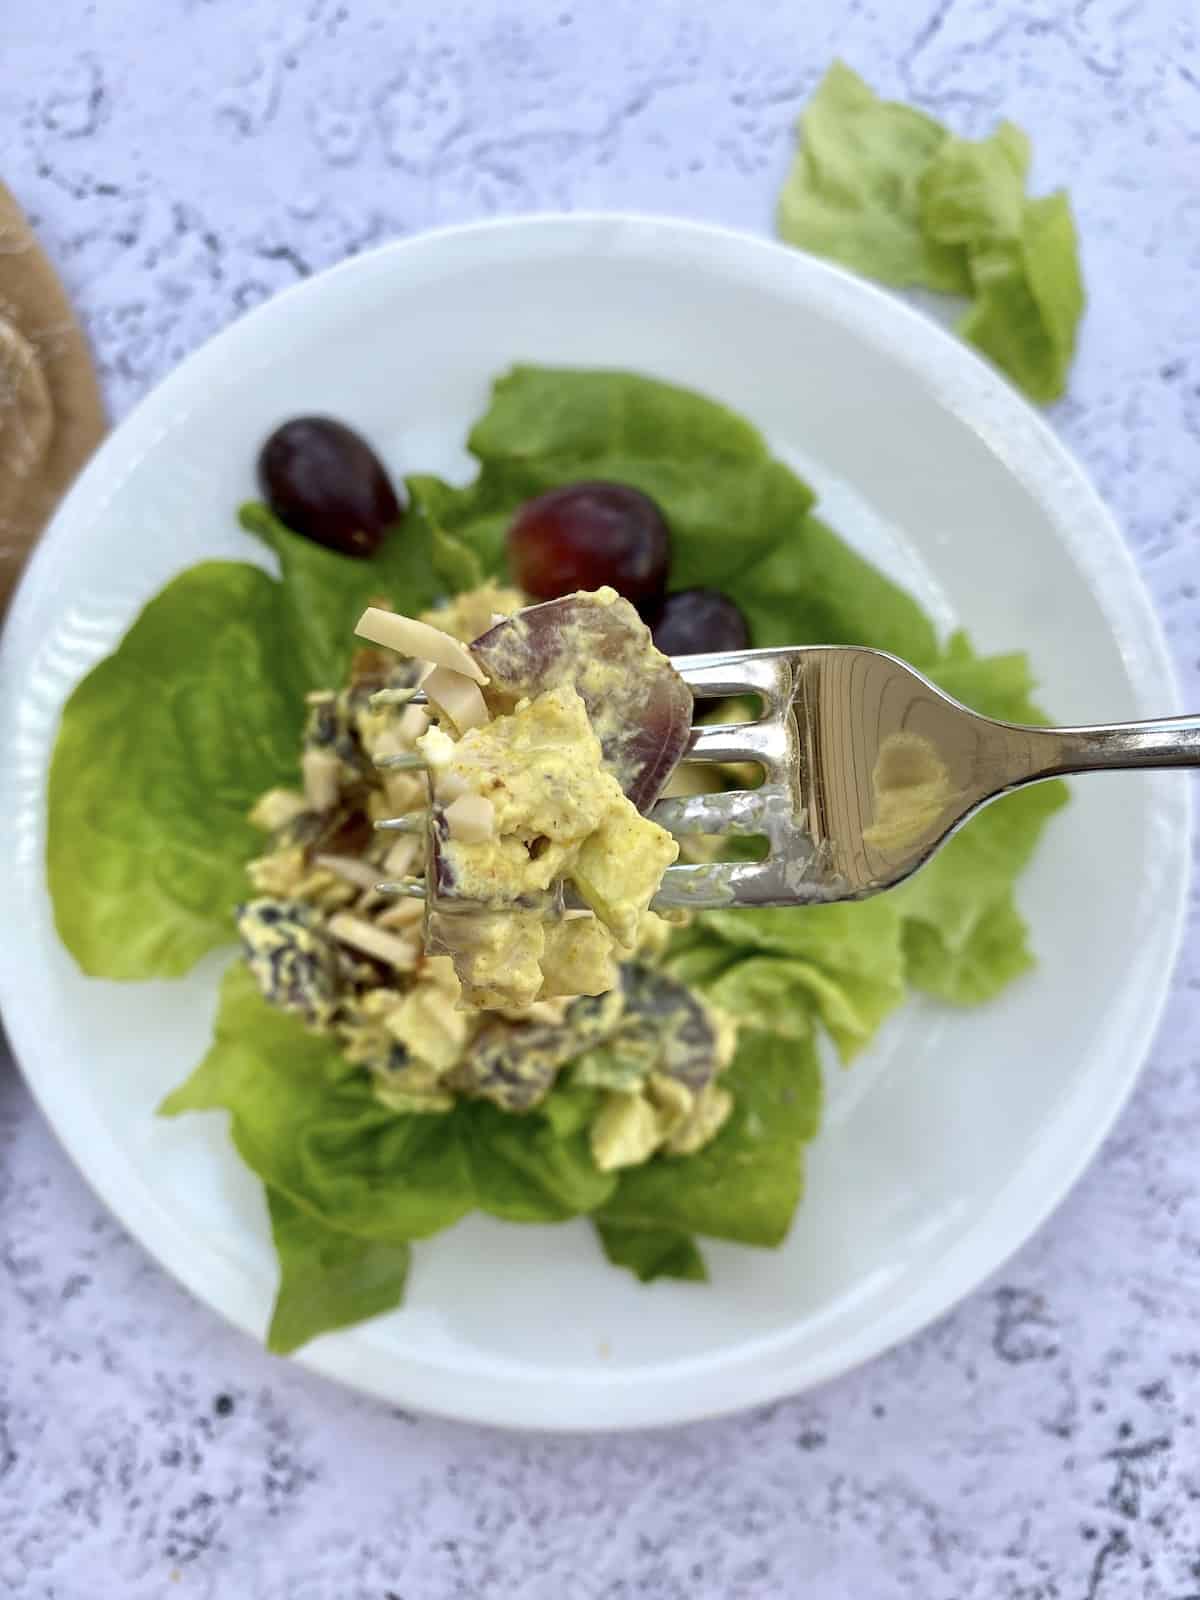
left=46, top=562, right=304, bottom=978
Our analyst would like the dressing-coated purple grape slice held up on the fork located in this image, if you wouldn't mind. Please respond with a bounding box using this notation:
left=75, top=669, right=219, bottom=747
left=470, top=595, right=693, bottom=811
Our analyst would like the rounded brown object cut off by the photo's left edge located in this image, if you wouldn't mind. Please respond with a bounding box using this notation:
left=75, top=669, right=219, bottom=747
left=0, top=182, right=106, bottom=614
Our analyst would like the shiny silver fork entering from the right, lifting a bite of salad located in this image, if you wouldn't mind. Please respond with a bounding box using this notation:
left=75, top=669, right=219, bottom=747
left=378, top=645, right=1200, bottom=910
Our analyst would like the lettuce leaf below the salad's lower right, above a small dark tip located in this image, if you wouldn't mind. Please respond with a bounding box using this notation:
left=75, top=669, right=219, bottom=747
left=598, top=1029, right=821, bottom=1245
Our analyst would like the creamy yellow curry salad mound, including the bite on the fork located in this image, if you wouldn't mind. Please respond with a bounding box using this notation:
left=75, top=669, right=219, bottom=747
left=238, top=586, right=736, bottom=1171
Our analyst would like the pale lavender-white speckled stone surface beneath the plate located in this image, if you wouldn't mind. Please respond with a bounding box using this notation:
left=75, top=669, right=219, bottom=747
left=0, top=0, right=1200, bottom=1600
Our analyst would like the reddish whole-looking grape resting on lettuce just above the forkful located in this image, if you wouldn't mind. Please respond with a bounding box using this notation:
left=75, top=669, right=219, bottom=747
left=509, top=480, right=670, bottom=608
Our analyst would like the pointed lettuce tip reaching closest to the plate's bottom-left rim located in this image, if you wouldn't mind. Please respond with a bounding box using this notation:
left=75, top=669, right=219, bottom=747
left=267, top=1189, right=411, bottom=1355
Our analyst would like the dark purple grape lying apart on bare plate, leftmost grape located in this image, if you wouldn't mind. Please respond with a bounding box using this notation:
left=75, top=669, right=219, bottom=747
left=258, top=416, right=403, bottom=555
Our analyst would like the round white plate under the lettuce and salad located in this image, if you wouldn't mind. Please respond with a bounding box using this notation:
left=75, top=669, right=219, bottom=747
left=0, top=216, right=1189, bottom=1427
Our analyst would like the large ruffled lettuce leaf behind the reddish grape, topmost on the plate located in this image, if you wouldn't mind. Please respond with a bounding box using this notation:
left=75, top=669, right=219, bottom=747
left=410, top=366, right=938, bottom=664
